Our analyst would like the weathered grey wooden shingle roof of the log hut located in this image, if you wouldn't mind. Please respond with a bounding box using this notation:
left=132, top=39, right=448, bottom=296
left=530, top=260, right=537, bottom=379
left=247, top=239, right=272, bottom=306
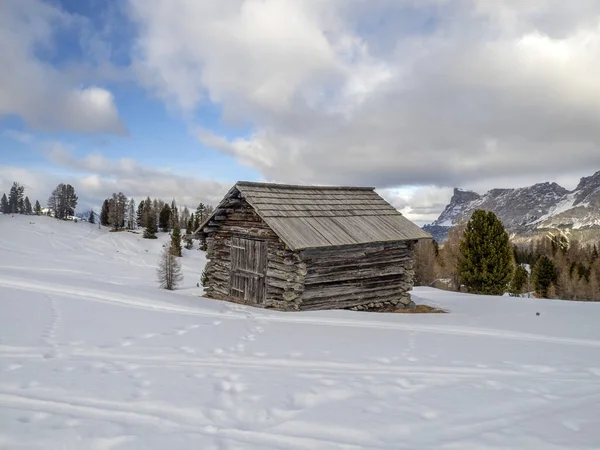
left=205, top=181, right=431, bottom=250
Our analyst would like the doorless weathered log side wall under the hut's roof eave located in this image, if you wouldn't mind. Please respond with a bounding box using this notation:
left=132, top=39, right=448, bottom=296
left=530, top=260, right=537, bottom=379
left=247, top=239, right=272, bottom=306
left=300, top=241, right=415, bottom=310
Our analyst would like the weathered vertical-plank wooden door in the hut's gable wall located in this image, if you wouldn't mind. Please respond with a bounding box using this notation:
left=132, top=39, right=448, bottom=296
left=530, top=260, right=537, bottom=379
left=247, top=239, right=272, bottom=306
left=229, top=236, right=267, bottom=304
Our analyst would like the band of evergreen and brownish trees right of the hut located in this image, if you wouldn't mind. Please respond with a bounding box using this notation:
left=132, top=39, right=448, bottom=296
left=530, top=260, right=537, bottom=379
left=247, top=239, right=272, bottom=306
left=415, top=210, right=600, bottom=301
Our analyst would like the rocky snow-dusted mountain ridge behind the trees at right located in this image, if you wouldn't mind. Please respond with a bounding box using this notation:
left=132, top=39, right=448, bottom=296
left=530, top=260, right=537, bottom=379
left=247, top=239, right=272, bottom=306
left=424, top=171, right=600, bottom=239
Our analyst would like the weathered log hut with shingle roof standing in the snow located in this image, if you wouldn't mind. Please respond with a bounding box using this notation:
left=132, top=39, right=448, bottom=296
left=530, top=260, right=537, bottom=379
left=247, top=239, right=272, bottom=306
left=196, top=182, right=431, bottom=310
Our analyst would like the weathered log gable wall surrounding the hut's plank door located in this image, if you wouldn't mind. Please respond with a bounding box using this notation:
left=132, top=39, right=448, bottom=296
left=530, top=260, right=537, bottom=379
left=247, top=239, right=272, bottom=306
left=205, top=200, right=306, bottom=310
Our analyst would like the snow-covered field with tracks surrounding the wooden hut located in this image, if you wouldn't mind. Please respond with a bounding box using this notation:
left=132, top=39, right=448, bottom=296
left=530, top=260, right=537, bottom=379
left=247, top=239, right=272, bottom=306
left=0, top=215, right=600, bottom=450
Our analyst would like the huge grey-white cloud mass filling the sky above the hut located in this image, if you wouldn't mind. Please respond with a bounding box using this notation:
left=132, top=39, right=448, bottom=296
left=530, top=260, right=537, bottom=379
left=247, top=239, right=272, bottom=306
left=130, top=0, right=600, bottom=201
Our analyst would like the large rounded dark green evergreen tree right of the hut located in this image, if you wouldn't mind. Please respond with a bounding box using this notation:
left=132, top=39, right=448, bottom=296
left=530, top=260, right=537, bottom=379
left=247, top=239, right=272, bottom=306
left=459, top=210, right=512, bottom=295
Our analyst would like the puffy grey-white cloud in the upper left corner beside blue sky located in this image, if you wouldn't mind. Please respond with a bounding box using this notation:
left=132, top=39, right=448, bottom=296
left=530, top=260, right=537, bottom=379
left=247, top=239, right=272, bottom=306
left=0, top=0, right=127, bottom=134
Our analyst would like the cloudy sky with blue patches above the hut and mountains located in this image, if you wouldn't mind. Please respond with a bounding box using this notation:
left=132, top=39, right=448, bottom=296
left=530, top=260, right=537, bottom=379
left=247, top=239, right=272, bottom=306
left=0, top=0, right=600, bottom=224
